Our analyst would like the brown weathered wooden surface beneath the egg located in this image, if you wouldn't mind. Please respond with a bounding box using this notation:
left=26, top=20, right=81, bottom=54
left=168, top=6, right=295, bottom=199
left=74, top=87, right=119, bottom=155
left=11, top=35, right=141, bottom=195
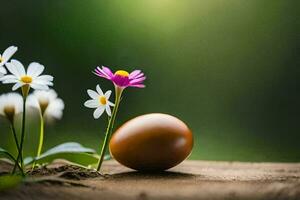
left=0, top=161, right=300, bottom=200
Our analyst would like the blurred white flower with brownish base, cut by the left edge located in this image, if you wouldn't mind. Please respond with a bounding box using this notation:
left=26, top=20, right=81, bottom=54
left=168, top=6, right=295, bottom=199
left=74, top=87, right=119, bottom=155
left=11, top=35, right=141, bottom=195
left=0, top=92, right=23, bottom=121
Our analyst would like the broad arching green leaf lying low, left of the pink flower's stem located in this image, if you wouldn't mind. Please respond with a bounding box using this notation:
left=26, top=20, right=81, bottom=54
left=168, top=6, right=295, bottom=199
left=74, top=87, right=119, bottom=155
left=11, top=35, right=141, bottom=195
left=24, top=142, right=99, bottom=166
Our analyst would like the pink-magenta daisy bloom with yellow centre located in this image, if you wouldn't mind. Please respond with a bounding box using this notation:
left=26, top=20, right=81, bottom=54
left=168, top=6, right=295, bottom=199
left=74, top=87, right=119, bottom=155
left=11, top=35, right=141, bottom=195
left=94, top=66, right=146, bottom=89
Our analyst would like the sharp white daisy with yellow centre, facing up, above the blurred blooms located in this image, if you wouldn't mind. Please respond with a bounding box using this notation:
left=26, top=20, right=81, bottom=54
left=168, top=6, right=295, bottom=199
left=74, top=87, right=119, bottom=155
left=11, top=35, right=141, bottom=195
left=0, top=60, right=53, bottom=90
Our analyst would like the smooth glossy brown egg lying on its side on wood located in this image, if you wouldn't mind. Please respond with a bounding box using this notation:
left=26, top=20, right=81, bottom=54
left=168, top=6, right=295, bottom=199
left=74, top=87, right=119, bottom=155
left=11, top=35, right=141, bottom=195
left=109, top=113, right=193, bottom=171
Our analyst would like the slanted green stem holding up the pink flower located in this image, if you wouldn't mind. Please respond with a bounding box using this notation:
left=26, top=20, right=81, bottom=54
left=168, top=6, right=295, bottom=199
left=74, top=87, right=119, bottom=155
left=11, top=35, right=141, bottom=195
left=97, top=86, right=123, bottom=171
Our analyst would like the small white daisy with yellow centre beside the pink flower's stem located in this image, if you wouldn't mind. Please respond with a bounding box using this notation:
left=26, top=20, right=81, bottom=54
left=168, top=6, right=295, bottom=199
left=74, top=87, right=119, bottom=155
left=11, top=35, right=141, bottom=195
left=84, top=85, right=114, bottom=119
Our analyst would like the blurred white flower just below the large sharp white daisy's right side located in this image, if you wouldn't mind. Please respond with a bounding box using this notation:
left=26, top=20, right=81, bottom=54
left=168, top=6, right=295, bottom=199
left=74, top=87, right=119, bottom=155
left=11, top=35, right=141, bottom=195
left=28, top=89, right=65, bottom=119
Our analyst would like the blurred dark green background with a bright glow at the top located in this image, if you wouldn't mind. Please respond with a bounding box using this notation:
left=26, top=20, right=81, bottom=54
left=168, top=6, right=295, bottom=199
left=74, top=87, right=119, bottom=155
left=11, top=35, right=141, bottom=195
left=0, top=0, right=300, bottom=162
